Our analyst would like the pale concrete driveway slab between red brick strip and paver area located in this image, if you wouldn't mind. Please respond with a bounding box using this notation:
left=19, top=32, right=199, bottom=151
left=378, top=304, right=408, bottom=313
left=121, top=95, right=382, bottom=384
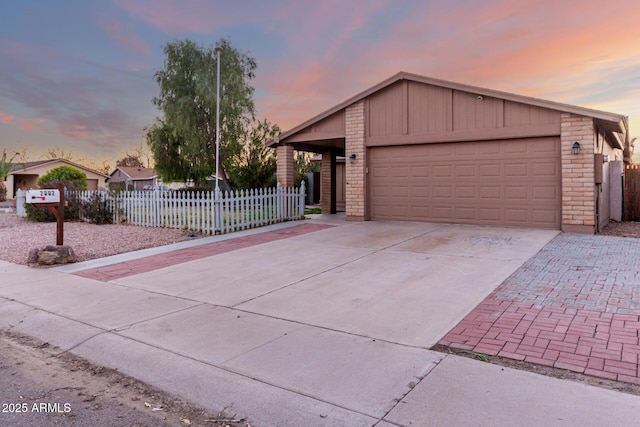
left=116, top=222, right=557, bottom=348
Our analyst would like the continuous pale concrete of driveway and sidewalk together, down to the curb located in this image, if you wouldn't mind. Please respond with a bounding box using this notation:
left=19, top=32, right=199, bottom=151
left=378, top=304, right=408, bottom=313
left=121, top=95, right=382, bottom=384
left=0, top=222, right=640, bottom=426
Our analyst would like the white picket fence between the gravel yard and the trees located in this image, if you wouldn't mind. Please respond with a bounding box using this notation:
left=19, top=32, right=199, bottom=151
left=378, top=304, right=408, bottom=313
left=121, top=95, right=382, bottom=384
left=18, top=181, right=305, bottom=234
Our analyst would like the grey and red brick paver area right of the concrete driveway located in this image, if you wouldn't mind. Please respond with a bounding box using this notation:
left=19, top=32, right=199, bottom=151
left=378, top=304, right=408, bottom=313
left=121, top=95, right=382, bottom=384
left=439, top=234, right=640, bottom=384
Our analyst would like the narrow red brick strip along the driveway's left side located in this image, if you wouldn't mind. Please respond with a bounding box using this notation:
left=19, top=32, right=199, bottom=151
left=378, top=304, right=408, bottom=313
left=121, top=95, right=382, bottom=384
left=74, top=224, right=332, bottom=282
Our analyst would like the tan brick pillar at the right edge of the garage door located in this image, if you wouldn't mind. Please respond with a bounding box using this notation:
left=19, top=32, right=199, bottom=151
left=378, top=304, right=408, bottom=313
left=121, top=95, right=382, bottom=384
left=560, top=113, right=596, bottom=234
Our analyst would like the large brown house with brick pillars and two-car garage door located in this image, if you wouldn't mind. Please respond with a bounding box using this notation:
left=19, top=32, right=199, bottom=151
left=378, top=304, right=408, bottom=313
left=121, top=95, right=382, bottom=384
left=268, top=72, right=629, bottom=233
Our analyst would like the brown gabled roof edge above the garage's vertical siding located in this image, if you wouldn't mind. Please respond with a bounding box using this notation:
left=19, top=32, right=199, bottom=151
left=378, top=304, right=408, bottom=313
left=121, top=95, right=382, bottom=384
left=267, top=71, right=627, bottom=148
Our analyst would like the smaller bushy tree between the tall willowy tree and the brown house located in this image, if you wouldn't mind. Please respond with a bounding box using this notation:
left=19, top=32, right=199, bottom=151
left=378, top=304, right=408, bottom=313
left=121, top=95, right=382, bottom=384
left=227, top=120, right=280, bottom=189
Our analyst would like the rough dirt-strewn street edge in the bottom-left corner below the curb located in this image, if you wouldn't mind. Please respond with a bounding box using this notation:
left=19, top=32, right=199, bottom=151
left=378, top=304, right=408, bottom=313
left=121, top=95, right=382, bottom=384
left=0, top=332, right=251, bottom=427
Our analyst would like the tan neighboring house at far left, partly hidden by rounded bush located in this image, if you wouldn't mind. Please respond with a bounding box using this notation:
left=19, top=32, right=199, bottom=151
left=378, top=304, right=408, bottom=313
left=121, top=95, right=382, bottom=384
left=6, top=159, right=109, bottom=198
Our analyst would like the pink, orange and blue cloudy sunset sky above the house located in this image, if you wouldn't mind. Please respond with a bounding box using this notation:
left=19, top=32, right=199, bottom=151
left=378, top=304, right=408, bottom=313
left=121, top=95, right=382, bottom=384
left=0, top=0, right=640, bottom=164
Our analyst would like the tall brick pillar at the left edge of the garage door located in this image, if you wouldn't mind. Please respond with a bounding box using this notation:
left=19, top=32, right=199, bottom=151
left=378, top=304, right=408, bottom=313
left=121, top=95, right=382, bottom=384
left=345, top=101, right=367, bottom=221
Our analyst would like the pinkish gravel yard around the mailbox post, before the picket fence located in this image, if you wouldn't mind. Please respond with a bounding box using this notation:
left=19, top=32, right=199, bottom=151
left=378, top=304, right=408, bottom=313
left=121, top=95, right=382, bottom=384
left=0, top=213, right=201, bottom=264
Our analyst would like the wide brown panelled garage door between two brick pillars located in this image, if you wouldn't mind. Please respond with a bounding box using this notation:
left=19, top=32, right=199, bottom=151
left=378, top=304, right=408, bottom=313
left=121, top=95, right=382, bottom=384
left=368, top=138, right=561, bottom=229
